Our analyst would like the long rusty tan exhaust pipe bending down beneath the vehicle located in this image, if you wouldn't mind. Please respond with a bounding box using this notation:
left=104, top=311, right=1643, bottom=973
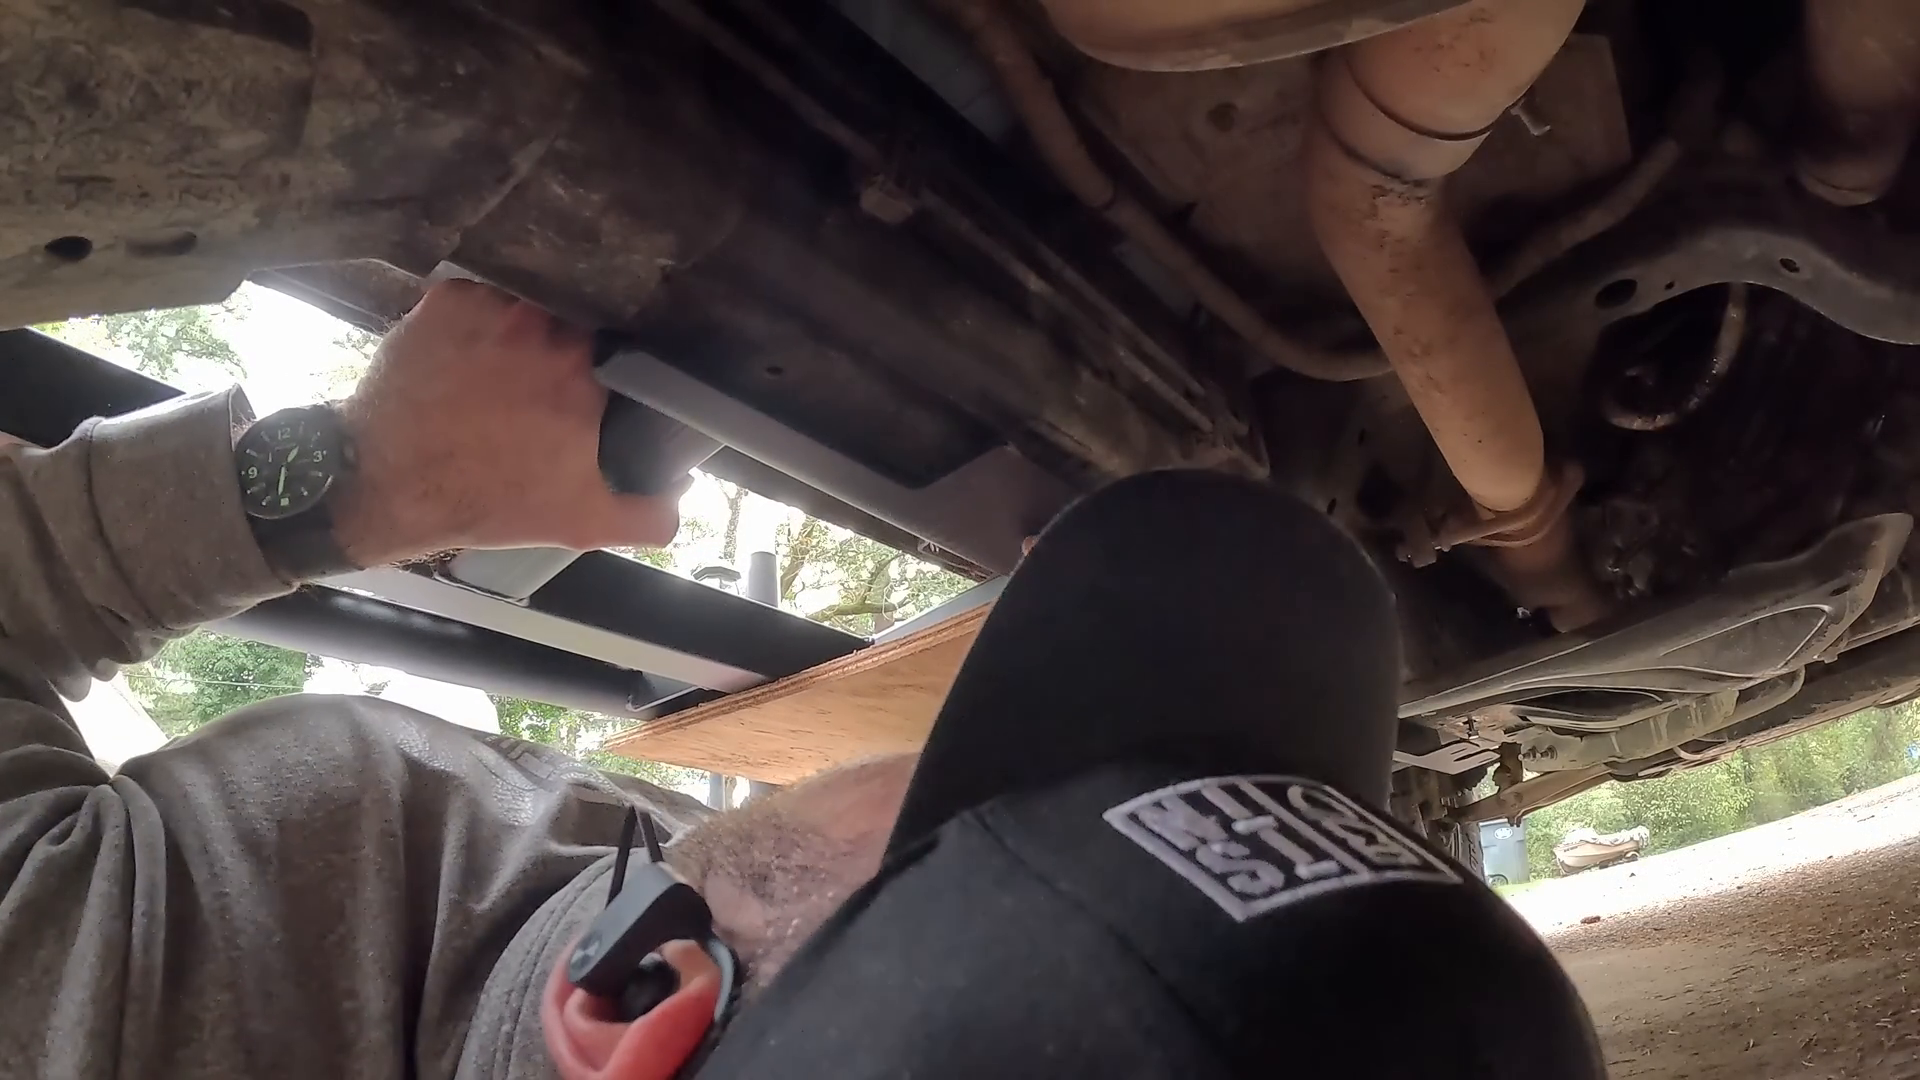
left=1306, top=0, right=1607, bottom=630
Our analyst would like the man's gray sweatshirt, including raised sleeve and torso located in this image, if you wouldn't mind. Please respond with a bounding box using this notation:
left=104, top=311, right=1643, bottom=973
left=0, top=394, right=705, bottom=1080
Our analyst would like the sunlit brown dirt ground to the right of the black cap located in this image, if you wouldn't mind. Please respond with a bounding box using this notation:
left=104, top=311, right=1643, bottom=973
left=1511, top=776, right=1920, bottom=1080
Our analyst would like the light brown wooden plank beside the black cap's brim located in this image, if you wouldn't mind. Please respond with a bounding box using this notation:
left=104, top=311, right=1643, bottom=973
left=607, top=605, right=991, bottom=784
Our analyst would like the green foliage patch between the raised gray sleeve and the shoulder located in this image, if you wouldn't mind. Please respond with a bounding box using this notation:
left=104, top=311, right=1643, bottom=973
left=127, top=630, right=319, bottom=736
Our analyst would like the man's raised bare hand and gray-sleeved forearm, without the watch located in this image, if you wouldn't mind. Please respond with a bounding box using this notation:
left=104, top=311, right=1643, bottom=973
left=0, top=281, right=691, bottom=718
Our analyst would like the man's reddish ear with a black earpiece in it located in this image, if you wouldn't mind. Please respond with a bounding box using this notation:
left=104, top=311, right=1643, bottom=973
left=540, top=942, right=720, bottom=1080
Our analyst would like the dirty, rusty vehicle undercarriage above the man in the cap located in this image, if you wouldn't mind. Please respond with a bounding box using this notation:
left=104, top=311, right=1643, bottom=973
left=0, top=0, right=1920, bottom=849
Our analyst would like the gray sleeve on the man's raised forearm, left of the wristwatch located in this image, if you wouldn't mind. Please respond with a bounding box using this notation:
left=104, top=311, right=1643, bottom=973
left=0, top=390, right=288, bottom=700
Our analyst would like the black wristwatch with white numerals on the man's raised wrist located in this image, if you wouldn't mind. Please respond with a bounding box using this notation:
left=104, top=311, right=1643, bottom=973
left=234, top=405, right=359, bottom=582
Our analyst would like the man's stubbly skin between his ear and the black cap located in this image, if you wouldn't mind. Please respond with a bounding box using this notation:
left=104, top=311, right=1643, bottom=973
left=666, top=755, right=914, bottom=986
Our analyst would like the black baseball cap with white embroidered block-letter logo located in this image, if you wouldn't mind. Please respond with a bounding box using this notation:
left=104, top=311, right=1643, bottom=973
left=699, top=471, right=1605, bottom=1080
